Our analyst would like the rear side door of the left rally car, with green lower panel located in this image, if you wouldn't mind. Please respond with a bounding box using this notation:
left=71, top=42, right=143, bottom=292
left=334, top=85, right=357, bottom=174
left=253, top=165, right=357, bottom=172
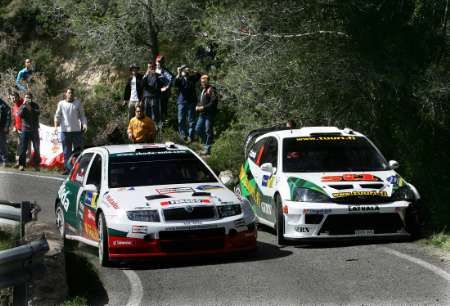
left=59, top=153, right=94, bottom=235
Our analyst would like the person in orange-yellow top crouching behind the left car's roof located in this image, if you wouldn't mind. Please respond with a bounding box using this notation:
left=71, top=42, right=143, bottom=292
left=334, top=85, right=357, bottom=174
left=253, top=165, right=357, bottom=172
left=128, top=105, right=156, bottom=143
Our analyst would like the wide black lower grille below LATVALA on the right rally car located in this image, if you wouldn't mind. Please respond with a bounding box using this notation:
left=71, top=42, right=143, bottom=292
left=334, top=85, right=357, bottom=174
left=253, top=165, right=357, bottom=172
left=319, top=213, right=403, bottom=235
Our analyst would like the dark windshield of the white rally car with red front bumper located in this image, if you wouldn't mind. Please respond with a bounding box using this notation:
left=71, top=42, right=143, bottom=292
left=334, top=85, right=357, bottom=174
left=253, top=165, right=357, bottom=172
left=108, top=149, right=217, bottom=188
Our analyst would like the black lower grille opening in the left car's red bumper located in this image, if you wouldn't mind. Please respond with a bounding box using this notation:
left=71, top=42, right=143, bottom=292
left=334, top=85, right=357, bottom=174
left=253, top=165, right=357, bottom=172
left=159, top=228, right=225, bottom=253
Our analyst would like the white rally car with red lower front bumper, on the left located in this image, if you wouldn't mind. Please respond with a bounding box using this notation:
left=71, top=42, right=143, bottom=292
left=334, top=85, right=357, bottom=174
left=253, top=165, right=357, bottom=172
left=55, top=144, right=256, bottom=265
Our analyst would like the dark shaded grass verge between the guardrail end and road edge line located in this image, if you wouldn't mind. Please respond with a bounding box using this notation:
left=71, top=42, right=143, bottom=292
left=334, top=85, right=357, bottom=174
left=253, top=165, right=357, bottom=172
left=63, top=252, right=108, bottom=306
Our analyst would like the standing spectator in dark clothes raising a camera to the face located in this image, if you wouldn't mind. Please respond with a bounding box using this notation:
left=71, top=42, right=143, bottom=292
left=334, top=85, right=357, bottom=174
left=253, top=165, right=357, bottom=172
left=175, top=65, right=200, bottom=143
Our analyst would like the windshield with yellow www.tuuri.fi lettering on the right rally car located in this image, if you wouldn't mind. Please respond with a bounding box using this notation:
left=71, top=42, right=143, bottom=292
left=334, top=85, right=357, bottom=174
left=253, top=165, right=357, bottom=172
left=283, top=136, right=388, bottom=172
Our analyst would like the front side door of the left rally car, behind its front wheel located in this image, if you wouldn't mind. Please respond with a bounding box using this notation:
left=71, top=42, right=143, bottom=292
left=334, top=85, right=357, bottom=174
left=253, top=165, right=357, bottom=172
left=77, top=154, right=102, bottom=241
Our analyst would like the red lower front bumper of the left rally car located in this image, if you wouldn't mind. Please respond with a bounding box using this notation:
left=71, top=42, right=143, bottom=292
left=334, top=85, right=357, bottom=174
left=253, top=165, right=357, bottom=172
left=108, top=229, right=257, bottom=260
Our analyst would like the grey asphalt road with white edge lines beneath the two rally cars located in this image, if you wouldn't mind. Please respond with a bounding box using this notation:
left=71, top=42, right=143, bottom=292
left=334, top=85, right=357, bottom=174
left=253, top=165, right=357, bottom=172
left=0, top=171, right=450, bottom=305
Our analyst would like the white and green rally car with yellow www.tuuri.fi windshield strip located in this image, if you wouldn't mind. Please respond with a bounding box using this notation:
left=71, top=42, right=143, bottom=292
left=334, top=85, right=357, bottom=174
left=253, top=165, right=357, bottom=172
left=235, top=127, right=420, bottom=244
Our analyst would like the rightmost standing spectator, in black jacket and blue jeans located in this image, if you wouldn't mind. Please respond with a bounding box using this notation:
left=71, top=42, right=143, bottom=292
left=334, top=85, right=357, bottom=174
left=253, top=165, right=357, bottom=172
left=195, top=74, right=218, bottom=154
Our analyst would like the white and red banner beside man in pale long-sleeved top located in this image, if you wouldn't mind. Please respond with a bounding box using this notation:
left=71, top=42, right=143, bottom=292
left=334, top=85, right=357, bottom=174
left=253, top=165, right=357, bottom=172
left=39, top=123, right=64, bottom=169
